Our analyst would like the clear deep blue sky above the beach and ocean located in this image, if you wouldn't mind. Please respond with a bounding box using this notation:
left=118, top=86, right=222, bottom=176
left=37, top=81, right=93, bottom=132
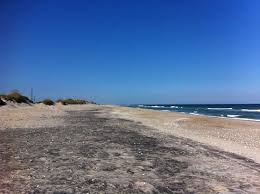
left=0, top=0, right=260, bottom=104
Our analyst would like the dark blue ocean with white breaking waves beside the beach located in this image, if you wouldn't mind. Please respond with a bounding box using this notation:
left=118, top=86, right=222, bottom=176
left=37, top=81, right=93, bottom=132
left=130, top=104, right=260, bottom=121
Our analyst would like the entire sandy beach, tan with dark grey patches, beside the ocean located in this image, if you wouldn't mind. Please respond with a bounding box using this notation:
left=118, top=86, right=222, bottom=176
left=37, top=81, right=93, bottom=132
left=0, top=105, right=260, bottom=193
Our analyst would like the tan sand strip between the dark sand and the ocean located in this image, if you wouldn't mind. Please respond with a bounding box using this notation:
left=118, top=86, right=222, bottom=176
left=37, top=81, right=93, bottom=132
left=106, top=106, right=260, bottom=163
